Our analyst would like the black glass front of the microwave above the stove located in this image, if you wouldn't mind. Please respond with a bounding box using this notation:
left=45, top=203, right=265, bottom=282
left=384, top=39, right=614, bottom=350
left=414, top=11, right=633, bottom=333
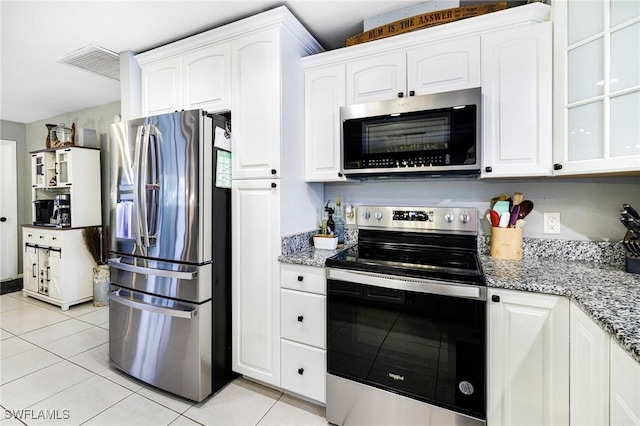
left=342, top=105, right=478, bottom=170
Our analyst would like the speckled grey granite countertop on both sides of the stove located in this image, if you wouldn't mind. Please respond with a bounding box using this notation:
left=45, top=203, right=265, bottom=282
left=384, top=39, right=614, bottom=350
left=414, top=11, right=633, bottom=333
left=278, top=247, right=640, bottom=362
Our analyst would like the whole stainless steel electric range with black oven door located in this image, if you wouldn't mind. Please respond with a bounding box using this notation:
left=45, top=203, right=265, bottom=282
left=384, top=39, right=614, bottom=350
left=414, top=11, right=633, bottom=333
left=326, top=206, right=486, bottom=425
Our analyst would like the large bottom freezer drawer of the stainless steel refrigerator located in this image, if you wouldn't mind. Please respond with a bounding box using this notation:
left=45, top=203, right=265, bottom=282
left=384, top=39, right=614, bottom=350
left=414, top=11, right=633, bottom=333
left=109, top=286, right=212, bottom=402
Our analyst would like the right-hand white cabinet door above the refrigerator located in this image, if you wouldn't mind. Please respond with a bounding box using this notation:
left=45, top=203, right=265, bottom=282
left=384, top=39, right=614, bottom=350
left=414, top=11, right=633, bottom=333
left=182, top=43, right=230, bottom=112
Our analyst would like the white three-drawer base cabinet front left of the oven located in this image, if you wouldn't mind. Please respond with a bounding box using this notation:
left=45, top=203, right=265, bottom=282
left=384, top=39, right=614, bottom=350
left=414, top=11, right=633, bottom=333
left=280, top=264, right=327, bottom=403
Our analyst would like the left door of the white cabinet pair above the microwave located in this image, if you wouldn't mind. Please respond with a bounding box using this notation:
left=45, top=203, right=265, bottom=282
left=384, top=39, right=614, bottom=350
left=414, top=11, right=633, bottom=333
left=347, top=52, right=407, bottom=105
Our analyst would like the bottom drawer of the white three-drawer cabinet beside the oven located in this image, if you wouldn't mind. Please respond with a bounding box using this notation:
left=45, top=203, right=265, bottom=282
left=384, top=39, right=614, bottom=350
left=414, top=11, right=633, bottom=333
left=280, top=340, right=327, bottom=403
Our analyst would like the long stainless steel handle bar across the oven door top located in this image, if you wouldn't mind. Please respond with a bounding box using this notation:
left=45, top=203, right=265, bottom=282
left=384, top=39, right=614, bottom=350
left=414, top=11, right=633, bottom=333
left=327, top=268, right=487, bottom=300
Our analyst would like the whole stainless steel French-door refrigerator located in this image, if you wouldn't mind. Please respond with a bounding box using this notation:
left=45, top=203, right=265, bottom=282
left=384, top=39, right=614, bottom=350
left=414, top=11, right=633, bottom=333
left=109, top=110, right=233, bottom=401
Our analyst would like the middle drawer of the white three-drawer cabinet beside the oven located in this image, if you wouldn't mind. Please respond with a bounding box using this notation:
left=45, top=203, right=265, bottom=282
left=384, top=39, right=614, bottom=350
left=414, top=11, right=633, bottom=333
left=280, top=289, right=326, bottom=349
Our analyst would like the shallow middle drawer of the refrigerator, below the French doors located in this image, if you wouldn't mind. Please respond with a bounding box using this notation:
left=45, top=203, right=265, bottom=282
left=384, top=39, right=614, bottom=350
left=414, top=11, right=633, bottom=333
left=109, top=256, right=211, bottom=303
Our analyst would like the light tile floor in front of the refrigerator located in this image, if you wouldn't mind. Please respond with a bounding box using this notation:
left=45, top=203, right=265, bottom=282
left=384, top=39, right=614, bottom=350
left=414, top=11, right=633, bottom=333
left=0, top=292, right=327, bottom=426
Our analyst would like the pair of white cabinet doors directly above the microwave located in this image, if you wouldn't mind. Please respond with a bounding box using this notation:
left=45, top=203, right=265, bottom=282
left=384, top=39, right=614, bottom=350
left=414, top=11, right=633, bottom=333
left=346, top=37, right=480, bottom=105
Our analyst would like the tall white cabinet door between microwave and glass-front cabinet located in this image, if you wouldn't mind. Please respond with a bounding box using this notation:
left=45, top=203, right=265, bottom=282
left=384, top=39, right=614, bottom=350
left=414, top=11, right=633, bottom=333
left=482, top=22, right=552, bottom=178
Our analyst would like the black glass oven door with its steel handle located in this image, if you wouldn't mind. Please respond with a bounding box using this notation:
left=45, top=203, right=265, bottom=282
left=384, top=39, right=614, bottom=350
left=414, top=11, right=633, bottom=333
left=327, top=269, right=486, bottom=419
